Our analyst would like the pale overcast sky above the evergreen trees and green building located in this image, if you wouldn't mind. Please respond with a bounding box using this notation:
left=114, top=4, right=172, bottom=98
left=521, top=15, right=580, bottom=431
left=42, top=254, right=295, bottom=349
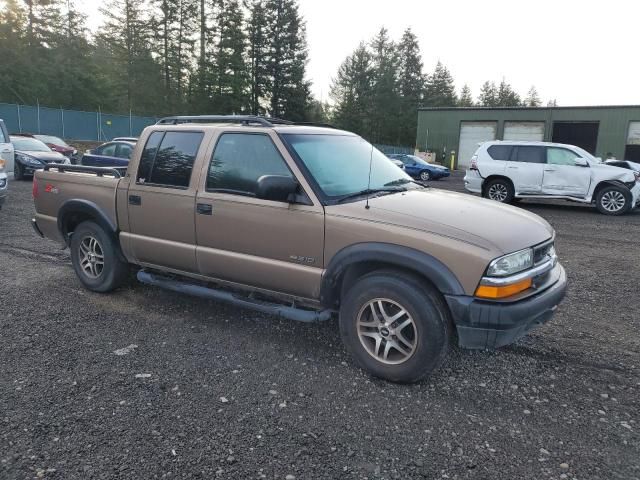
left=78, top=0, right=640, bottom=106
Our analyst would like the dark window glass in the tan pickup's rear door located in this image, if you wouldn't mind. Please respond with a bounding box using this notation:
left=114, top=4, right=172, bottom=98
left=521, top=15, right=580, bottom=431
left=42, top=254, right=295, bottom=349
left=136, top=131, right=204, bottom=189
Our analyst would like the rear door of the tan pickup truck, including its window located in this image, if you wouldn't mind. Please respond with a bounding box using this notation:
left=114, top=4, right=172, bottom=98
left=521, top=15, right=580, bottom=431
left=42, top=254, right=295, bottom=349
left=127, top=131, right=204, bottom=273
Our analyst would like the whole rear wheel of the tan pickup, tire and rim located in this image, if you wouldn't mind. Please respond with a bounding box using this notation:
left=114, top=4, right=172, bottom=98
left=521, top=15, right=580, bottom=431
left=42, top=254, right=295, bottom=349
left=70, top=221, right=129, bottom=293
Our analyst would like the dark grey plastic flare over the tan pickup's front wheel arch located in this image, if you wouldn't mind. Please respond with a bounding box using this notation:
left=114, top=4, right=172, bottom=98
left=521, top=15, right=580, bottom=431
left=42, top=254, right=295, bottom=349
left=320, top=242, right=465, bottom=305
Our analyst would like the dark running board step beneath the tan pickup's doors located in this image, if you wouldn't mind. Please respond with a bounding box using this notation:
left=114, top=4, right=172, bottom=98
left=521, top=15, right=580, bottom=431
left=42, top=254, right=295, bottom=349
left=137, top=270, right=332, bottom=323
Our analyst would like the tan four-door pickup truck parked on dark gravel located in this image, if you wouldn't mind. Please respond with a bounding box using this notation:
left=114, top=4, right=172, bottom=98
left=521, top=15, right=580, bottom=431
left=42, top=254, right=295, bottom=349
left=33, top=116, right=566, bottom=382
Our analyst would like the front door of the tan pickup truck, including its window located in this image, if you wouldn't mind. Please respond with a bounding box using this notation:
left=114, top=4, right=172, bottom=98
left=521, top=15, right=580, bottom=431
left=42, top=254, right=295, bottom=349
left=196, top=132, right=324, bottom=299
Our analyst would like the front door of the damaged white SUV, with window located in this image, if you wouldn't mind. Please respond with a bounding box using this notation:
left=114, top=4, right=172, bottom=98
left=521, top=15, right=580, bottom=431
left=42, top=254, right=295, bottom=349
left=542, top=147, right=591, bottom=198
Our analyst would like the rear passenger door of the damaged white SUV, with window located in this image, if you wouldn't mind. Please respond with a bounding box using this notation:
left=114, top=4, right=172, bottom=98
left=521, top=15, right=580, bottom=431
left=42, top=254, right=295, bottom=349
left=505, top=145, right=545, bottom=195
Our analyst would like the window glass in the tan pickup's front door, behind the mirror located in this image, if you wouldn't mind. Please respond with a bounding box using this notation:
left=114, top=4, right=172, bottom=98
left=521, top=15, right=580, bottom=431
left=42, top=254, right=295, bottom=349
left=207, top=133, right=291, bottom=196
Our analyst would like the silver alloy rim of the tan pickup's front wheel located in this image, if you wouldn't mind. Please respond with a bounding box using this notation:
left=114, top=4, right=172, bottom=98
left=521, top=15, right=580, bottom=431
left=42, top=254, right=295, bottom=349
left=357, top=298, right=418, bottom=365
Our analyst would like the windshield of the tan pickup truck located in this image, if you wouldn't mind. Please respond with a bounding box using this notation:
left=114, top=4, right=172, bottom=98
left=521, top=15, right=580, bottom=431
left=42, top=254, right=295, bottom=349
left=283, top=134, right=411, bottom=198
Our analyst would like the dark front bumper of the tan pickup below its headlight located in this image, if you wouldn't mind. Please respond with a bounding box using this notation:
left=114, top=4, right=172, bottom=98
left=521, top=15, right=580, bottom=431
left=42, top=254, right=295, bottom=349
left=445, top=263, right=567, bottom=349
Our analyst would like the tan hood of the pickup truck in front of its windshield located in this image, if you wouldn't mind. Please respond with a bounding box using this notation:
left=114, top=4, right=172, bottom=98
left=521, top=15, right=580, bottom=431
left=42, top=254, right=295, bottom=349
left=327, top=188, right=554, bottom=254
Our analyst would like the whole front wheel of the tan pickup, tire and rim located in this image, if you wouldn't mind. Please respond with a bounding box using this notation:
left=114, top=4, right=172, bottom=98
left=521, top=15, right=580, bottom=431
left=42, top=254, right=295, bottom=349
left=340, top=271, right=452, bottom=383
